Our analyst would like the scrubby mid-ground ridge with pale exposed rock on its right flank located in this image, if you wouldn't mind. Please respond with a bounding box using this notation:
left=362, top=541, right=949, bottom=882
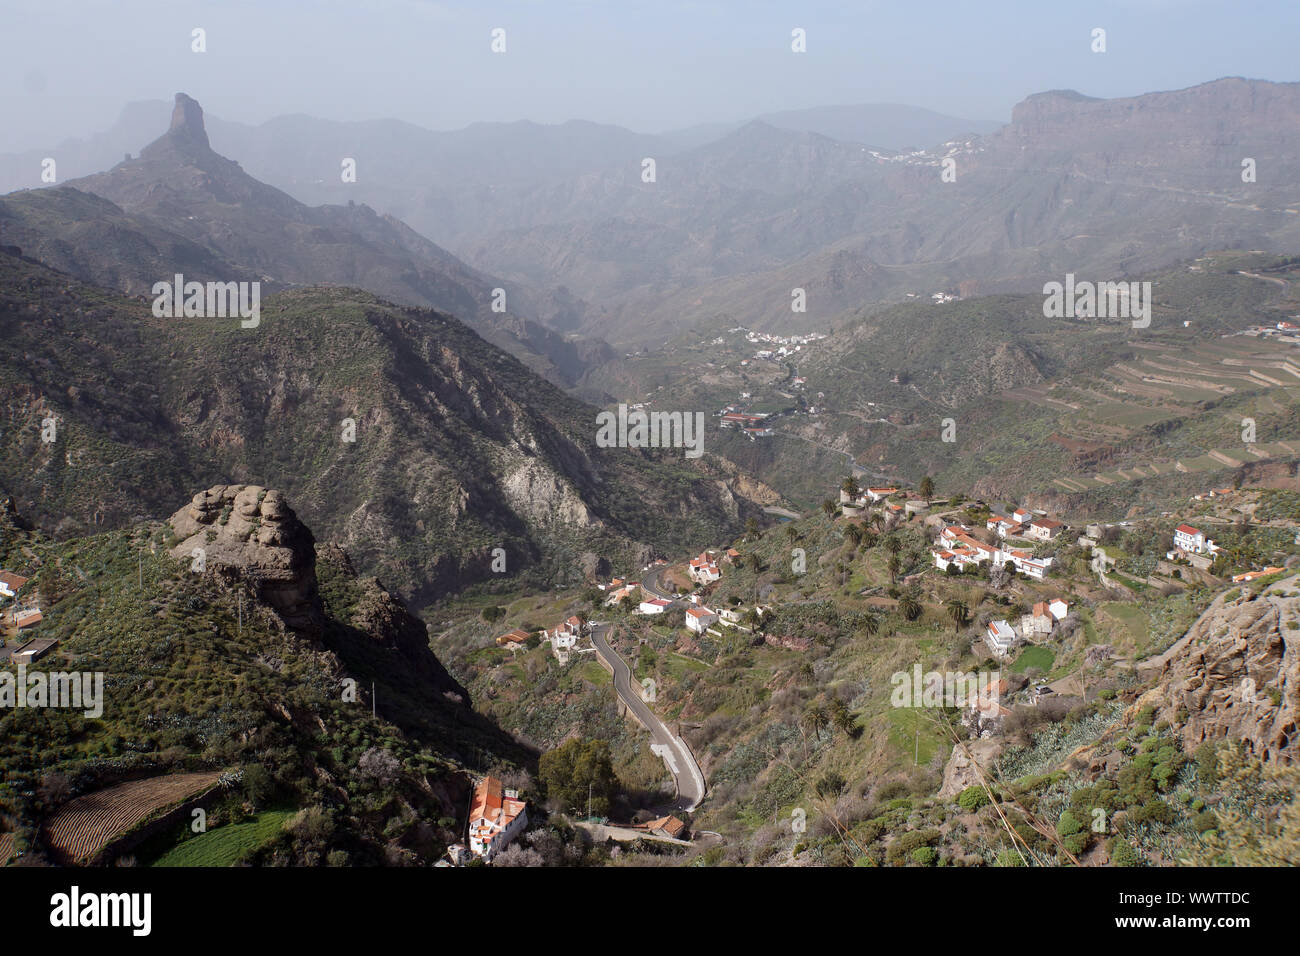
left=0, top=250, right=753, bottom=604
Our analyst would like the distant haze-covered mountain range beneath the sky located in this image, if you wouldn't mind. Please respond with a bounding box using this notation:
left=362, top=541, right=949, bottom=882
left=0, top=78, right=1300, bottom=348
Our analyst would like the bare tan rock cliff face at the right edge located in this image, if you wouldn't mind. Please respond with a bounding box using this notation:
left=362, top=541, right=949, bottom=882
left=1139, top=576, right=1300, bottom=763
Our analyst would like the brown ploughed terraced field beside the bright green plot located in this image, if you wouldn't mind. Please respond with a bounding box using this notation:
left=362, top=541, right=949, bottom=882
left=44, top=770, right=221, bottom=864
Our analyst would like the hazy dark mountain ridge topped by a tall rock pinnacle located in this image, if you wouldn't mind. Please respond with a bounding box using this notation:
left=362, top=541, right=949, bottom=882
left=0, top=94, right=610, bottom=384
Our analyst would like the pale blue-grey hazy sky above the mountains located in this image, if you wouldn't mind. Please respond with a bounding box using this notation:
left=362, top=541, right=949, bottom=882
left=0, top=0, right=1300, bottom=152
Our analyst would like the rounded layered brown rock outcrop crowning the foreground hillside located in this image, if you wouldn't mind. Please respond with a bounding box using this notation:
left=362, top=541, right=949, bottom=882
left=170, top=485, right=325, bottom=637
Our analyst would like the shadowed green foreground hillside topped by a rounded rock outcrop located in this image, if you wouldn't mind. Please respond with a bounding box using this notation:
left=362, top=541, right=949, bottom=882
left=0, top=486, right=517, bottom=865
